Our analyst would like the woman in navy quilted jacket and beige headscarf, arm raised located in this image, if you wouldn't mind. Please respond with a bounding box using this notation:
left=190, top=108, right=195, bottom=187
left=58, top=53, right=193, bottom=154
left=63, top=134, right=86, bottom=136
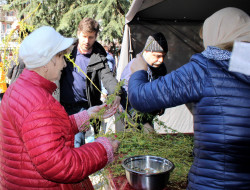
left=128, top=7, right=250, bottom=190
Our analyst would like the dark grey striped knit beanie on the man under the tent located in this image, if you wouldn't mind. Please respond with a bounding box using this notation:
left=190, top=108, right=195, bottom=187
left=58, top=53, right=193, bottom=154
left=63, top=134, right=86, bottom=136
left=144, top=32, right=168, bottom=53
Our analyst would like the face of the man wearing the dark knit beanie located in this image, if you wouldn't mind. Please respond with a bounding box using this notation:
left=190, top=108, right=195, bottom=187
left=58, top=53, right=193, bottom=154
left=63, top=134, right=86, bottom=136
left=143, top=51, right=166, bottom=67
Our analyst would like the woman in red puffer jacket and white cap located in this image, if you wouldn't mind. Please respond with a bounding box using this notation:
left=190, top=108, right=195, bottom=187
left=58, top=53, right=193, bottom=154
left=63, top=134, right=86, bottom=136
left=0, top=26, right=119, bottom=190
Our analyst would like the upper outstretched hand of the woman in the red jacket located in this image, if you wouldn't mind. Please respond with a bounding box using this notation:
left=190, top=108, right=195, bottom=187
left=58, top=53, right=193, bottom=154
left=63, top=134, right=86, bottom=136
left=87, top=104, right=116, bottom=119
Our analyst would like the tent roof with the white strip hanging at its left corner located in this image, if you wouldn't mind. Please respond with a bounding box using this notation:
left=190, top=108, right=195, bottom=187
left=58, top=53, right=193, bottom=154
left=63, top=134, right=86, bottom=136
left=117, top=0, right=250, bottom=80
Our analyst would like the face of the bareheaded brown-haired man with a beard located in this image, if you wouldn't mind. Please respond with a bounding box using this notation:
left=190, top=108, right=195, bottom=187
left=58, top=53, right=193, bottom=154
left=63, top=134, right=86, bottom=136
left=77, top=32, right=97, bottom=51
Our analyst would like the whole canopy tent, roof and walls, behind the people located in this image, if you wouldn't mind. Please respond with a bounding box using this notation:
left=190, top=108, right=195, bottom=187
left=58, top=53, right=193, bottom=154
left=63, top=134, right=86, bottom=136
left=117, top=0, right=250, bottom=133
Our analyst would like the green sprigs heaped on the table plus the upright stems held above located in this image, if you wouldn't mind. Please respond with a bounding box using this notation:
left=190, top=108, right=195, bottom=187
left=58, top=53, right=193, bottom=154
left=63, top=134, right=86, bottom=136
left=84, top=78, right=193, bottom=190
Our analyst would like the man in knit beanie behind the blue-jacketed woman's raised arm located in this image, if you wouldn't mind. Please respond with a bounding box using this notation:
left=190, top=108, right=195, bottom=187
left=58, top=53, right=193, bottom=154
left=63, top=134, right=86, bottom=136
left=121, top=32, right=168, bottom=132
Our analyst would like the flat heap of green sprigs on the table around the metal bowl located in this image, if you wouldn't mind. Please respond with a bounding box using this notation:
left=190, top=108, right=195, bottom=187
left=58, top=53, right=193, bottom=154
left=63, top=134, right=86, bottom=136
left=98, top=130, right=193, bottom=189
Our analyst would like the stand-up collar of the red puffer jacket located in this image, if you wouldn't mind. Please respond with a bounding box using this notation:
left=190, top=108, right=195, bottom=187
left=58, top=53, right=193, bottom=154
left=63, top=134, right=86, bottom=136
left=19, top=69, right=57, bottom=94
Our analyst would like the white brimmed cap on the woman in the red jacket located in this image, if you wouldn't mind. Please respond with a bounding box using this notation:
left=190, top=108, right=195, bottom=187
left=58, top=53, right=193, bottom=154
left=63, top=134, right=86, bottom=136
left=19, top=26, right=75, bottom=68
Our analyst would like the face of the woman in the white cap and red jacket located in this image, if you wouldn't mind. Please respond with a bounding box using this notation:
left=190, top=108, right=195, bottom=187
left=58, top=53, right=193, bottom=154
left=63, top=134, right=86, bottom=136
left=46, top=55, right=66, bottom=82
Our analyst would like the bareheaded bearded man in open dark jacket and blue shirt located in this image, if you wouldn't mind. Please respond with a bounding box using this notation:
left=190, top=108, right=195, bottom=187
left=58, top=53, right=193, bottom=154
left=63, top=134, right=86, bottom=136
left=60, top=18, right=121, bottom=144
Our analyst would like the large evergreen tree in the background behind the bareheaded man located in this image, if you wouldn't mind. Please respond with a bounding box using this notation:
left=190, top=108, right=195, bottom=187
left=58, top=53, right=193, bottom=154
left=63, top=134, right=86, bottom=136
left=5, top=0, right=132, bottom=42
